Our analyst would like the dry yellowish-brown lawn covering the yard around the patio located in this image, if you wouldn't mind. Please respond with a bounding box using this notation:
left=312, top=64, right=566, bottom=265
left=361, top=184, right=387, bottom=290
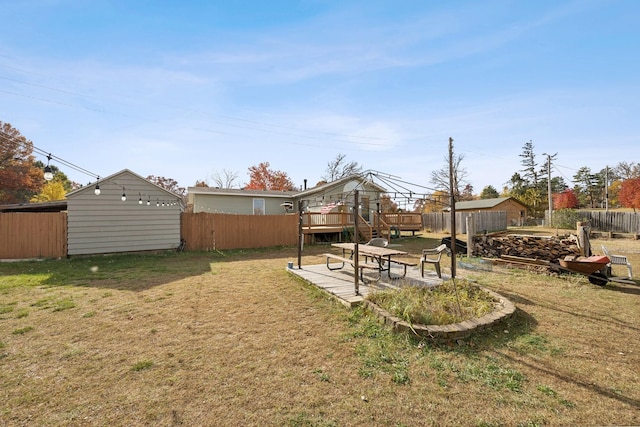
left=0, top=237, right=640, bottom=426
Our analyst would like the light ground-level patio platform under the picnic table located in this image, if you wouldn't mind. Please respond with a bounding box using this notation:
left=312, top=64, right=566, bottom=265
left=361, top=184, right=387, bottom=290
left=287, top=264, right=448, bottom=307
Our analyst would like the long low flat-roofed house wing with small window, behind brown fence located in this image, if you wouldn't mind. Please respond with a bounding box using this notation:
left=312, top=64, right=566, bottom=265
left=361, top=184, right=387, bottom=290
left=187, top=187, right=297, bottom=215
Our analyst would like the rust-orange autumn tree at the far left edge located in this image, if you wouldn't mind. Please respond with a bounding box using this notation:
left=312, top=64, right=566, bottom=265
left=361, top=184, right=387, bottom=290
left=0, top=121, right=45, bottom=204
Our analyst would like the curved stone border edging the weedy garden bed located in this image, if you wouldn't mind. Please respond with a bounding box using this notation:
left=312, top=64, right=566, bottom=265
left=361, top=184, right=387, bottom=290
left=362, top=287, right=516, bottom=341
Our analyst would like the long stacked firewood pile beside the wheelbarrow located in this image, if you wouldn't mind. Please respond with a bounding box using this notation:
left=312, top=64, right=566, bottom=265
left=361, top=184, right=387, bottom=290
left=473, top=235, right=580, bottom=263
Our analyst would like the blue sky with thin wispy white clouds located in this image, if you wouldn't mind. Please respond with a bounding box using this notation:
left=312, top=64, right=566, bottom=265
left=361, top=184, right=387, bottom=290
left=0, top=0, right=640, bottom=193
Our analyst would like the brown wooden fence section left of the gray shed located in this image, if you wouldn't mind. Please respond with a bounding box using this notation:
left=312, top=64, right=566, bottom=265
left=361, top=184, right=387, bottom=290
left=0, top=212, right=67, bottom=259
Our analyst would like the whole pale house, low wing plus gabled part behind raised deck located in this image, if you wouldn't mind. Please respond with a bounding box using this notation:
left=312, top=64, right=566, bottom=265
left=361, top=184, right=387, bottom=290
left=188, top=175, right=386, bottom=220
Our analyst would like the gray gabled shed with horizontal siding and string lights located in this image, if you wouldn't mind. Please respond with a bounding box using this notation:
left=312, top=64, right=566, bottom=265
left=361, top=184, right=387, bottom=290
left=67, top=169, right=182, bottom=255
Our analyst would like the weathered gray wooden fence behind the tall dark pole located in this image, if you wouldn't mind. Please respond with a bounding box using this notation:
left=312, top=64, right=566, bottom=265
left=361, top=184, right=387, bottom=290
left=422, top=211, right=507, bottom=234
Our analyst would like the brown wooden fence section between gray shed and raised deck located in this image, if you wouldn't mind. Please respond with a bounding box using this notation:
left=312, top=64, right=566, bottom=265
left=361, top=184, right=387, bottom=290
left=180, top=213, right=298, bottom=251
